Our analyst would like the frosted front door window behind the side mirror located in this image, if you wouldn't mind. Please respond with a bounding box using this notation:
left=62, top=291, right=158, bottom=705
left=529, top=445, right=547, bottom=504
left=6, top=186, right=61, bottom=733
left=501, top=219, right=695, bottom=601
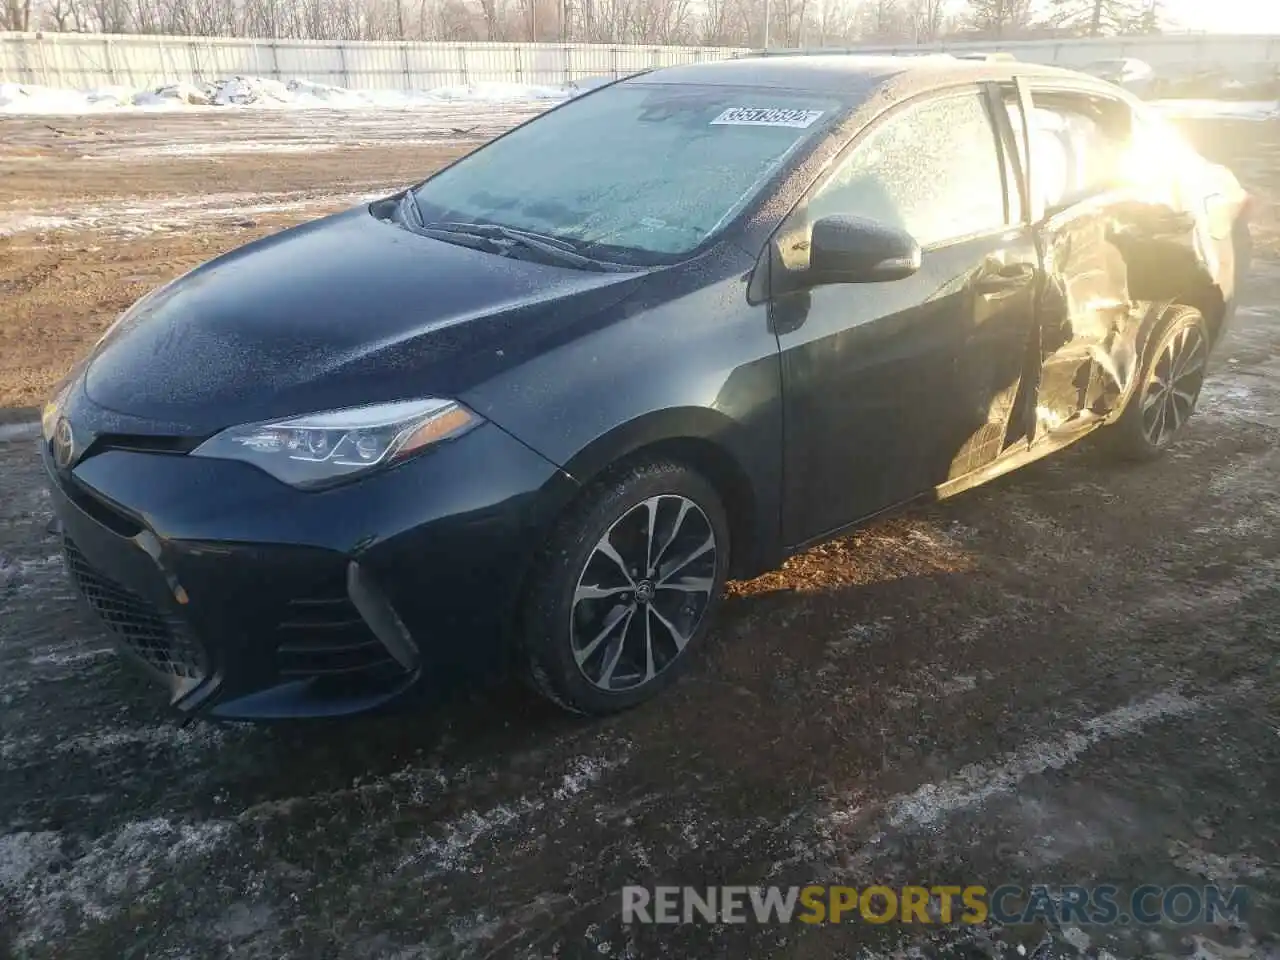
left=808, top=91, right=1006, bottom=246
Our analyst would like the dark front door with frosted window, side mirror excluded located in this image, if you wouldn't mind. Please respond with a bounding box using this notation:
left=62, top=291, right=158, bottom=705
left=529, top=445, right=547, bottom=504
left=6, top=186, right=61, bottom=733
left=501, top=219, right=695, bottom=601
left=771, top=86, right=1038, bottom=544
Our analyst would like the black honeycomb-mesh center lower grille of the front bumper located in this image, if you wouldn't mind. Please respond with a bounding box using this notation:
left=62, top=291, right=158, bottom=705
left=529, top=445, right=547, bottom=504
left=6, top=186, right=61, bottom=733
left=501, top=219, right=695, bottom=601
left=63, top=538, right=209, bottom=691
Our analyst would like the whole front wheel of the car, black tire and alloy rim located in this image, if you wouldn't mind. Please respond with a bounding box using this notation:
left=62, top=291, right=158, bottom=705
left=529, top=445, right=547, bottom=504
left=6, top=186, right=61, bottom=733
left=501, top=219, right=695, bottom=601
left=520, top=460, right=730, bottom=714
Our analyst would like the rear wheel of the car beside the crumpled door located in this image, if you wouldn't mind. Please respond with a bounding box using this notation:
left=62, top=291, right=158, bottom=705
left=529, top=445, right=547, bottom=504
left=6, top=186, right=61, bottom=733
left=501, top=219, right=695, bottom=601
left=1100, top=303, right=1211, bottom=461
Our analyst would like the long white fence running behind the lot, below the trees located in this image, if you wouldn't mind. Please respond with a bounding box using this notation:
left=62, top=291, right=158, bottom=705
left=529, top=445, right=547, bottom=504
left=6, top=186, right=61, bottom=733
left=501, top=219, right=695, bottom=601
left=0, top=33, right=1280, bottom=90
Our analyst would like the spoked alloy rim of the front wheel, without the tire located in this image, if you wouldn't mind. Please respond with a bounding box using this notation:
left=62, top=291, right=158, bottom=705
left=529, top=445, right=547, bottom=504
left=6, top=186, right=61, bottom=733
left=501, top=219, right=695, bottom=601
left=570, top=494, right=718, bottom=692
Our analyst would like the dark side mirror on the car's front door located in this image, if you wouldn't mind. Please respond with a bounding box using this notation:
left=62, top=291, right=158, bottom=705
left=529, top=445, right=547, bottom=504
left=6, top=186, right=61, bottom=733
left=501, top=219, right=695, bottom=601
left=806, top=214, right=922, bottom=287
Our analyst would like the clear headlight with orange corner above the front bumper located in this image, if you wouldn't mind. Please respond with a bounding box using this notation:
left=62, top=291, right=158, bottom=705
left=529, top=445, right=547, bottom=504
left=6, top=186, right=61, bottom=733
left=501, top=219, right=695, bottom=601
left=191, top=399, right=480, bottom=486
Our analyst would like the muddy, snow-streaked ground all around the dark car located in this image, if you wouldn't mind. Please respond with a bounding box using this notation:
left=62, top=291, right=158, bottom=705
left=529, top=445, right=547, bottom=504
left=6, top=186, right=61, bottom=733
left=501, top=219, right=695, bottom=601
left=0, top=108, right=1280, bottom=960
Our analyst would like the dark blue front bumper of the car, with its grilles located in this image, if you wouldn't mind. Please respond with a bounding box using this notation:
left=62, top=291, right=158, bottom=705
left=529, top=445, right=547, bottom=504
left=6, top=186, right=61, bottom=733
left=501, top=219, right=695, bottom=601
left=44, top=402, right=576, bottom=719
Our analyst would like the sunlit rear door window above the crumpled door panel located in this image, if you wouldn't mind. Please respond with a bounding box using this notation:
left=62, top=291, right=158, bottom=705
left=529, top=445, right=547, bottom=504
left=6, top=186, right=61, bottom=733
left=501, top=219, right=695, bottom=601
left=1029, top=95, right=1132, bottom=210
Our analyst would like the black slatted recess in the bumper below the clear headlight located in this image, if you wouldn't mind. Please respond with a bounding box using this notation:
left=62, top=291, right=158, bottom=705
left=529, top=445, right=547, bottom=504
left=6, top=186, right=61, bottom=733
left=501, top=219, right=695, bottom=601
left=275, top=582, right=403, bottom=680
